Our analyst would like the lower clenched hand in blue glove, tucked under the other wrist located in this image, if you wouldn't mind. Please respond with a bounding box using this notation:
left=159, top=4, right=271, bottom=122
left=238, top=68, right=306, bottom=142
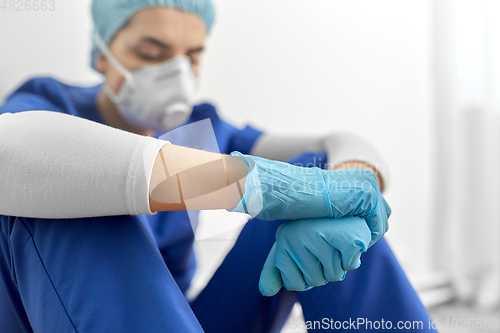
left=259, top=217, right=371, bottom=296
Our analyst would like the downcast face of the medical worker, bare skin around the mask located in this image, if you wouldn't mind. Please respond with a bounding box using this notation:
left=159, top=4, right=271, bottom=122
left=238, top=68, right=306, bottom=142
left=96, top=7, right=207, bottom=93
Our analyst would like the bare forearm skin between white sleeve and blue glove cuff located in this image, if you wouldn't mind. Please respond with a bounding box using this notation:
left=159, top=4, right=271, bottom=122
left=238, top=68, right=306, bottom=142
left=150, top=145, right=248, bottom=211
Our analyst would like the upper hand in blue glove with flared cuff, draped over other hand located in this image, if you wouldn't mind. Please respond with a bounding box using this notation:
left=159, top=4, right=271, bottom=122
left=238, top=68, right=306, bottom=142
left=229, top=152, right=391, bottom=246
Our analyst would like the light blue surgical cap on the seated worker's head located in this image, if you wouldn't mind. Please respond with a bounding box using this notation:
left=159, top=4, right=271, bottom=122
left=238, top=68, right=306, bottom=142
left=91, top=0, right=215, bottom=68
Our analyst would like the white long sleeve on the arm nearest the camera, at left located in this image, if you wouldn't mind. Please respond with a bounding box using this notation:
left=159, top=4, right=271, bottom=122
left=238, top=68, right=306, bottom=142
left=0, top=111, right=169, bottom=218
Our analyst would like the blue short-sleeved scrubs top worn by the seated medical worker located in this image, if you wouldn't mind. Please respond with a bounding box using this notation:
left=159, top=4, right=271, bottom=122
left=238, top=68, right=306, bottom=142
left=0, top=78, right=262, bottom=292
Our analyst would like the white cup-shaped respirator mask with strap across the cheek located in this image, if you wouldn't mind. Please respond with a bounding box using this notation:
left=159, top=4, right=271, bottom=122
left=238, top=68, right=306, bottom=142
left=94, top=32, right=198, bottom=131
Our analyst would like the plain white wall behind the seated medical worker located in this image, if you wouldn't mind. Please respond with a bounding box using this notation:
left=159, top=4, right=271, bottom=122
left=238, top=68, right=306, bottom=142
left=0, top=0, right=433, bottom=275
